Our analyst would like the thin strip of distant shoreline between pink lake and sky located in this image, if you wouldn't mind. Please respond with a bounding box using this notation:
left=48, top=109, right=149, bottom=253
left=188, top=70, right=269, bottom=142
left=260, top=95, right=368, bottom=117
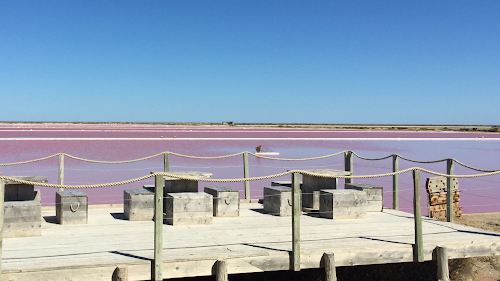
left=0, top=121, right=500, bottom=133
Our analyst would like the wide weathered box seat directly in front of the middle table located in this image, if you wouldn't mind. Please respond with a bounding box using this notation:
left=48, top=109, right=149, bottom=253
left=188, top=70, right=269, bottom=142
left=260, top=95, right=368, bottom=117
left=164, top=192, right=214, bottom=225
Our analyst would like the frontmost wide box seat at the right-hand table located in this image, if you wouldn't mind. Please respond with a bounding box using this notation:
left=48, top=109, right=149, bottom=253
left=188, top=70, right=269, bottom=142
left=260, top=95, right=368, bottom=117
left=319, top=189, right=366, bottom=219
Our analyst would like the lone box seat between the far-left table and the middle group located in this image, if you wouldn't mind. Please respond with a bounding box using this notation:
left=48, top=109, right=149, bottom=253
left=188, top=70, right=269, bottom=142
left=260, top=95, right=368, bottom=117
left=56, top=191, right=89, bottom=224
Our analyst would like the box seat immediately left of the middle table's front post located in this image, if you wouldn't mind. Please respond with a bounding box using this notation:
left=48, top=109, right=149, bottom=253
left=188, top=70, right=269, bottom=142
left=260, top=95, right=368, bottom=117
left=123, top=189, right=155, bottom=221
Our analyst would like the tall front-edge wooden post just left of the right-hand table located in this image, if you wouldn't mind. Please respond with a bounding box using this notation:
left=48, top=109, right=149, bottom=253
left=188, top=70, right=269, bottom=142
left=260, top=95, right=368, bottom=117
left=292, top=173, right=302, bottom=271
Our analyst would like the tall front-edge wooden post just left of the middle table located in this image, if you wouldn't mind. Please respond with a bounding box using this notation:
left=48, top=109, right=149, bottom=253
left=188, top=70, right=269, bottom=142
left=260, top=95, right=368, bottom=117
left=151, top=176, right=163, bottom=281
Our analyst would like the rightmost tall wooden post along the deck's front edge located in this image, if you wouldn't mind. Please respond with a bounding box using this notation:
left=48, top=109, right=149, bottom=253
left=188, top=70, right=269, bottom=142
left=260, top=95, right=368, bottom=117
left=413, top=170, right=424, bottom=262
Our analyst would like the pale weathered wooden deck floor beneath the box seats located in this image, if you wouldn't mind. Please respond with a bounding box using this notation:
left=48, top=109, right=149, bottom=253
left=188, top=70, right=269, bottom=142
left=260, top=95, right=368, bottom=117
left=2, top=203, right=500, bottom=280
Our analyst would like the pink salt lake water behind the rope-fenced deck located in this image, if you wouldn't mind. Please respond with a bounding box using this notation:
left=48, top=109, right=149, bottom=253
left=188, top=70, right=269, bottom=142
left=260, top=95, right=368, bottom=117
left=0, top=124, right=500, bottom=213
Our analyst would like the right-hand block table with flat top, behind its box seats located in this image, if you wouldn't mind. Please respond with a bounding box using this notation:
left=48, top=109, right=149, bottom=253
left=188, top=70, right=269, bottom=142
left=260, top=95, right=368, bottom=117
left=301, top=169, right=352, bottom=210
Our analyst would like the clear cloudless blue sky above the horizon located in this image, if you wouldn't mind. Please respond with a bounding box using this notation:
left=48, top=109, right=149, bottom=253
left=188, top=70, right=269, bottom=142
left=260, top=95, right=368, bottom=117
left=0, top=0, right=500, bottom=125
